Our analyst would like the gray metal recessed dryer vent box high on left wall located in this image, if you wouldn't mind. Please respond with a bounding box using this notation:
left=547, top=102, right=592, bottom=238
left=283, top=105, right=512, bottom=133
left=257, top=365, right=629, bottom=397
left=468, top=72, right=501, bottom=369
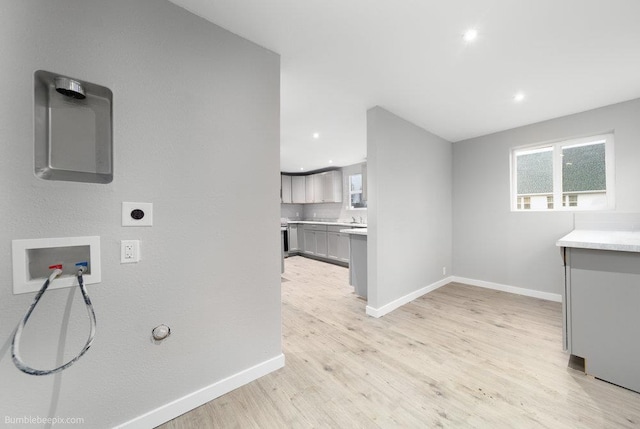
left=34, top=70, right=113, bottom=183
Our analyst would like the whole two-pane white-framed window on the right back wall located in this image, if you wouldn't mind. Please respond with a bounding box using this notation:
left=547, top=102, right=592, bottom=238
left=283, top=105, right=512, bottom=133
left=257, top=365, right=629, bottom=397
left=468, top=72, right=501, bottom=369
left=511, top=134, right=614, bottom=211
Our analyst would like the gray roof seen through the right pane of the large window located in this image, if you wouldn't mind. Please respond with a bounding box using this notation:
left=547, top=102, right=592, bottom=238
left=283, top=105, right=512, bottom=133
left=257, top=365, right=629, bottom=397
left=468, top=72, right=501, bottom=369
left=562, top=142, right=607, bottom=192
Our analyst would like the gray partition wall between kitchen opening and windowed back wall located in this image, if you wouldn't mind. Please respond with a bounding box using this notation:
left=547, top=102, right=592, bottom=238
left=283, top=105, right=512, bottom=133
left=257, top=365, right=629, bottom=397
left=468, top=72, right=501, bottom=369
left=367, top=107, right=452, bottom=308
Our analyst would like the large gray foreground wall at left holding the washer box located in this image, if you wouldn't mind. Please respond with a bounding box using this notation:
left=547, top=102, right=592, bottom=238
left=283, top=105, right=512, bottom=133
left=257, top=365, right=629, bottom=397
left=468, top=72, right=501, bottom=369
left=0, top=0, right=281, bottom=428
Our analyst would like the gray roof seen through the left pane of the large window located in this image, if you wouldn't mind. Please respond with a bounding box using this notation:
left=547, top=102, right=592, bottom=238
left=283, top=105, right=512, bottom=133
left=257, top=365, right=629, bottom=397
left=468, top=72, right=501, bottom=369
left=516, top=148, right=553, bottom=195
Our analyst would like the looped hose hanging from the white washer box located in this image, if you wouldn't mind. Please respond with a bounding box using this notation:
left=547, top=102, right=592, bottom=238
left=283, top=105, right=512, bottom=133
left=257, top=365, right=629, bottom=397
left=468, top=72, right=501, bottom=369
left=11, top=264, right=96, bottom=375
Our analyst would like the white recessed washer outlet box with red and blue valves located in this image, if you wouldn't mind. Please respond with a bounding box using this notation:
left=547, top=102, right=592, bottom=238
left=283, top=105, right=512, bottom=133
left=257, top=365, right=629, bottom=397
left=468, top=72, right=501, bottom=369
left=11, top=236, right=102, bottom=295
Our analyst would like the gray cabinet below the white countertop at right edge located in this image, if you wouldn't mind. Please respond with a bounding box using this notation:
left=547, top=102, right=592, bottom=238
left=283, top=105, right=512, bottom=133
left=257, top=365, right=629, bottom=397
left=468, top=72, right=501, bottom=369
left=563, top=248, right=640, bottom=392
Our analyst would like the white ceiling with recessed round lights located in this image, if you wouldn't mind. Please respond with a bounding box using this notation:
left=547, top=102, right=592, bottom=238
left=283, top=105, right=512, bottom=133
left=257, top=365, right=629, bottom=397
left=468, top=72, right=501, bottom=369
left=171, top=0, right=640, bottom=172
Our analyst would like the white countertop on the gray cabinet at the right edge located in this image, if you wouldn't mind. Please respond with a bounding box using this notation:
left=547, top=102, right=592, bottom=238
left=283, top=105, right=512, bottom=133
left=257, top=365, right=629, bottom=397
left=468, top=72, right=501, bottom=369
left=556, top=229, right=640, bottom=252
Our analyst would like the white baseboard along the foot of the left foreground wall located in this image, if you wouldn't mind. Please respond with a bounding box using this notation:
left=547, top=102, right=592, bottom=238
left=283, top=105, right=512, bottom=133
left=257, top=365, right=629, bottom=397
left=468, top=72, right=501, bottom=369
left=116, top=354, right=284, bottom=429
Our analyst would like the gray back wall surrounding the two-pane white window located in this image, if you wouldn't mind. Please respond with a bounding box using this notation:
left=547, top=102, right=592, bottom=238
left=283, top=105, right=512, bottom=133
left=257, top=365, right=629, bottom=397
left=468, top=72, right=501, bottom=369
left=453, top=100, right=640, bottom=294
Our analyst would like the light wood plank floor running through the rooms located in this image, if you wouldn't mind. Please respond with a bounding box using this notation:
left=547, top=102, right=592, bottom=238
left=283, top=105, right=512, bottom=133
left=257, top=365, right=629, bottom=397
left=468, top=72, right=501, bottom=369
left=161, top=257, right=640, bottom=429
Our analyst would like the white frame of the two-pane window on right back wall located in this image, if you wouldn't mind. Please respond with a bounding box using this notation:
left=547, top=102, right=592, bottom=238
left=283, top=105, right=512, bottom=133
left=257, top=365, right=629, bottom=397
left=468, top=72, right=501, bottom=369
left=510, top=132, right=615, bottom=212
